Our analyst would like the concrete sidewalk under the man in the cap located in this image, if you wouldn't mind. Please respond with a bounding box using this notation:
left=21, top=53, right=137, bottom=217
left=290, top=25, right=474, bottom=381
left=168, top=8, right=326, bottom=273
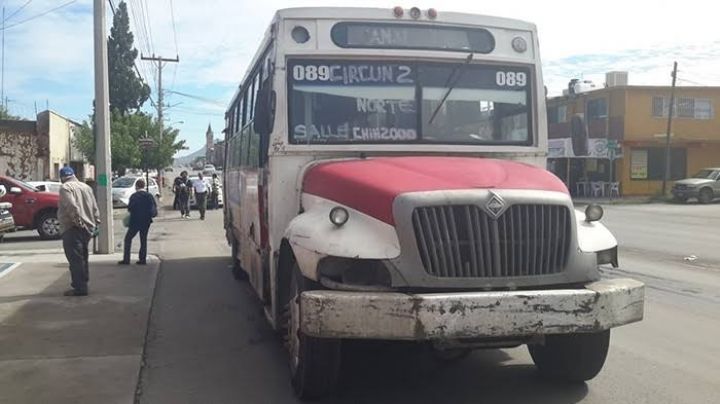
left=0, top=250, right=160, bottom=403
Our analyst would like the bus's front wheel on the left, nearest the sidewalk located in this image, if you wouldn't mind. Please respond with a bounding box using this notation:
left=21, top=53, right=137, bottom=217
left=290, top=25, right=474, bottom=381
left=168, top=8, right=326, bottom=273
left=283, top=264, right=341, bottom=399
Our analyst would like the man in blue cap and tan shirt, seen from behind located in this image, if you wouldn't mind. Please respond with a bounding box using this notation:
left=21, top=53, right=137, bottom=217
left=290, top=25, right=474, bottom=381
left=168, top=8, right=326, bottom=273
left=58, top=167, right=100, bottom=296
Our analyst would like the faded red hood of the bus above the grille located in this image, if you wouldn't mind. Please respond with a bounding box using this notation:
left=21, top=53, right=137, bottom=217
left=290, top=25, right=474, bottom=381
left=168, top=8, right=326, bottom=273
left=303, top=157, right=568, bottom=225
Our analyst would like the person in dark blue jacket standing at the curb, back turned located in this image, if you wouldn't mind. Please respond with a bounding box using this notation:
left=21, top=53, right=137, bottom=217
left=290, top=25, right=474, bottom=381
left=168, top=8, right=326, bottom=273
left=118, top=179, right=157, bottom=265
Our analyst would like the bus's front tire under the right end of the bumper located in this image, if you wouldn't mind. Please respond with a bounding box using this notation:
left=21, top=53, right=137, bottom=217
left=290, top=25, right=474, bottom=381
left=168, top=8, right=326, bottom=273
left=528, top=330, right=610, bottom=383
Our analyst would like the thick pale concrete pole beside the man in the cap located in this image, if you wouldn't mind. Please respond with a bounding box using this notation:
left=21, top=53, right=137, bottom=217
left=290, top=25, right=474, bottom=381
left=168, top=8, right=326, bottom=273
left=94, top=0, right=114, bottom=254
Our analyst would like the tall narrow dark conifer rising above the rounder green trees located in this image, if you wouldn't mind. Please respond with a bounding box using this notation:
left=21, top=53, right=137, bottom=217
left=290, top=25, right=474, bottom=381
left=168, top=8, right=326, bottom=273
left=108, top=1, right=150, bottom=115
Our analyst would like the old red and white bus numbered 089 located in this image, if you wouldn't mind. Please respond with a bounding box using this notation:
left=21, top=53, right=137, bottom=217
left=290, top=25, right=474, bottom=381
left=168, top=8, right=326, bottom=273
left=224, top=7, right=643, bottom=397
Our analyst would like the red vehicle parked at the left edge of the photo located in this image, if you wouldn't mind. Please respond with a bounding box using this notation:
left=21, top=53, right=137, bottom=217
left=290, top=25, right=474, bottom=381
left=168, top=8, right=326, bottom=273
left=0, top=176, right=60, bottom=240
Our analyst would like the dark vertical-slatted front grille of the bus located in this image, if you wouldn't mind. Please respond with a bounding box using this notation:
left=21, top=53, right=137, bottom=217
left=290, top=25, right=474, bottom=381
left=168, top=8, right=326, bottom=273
left=412, top=205, right=571, bottom=278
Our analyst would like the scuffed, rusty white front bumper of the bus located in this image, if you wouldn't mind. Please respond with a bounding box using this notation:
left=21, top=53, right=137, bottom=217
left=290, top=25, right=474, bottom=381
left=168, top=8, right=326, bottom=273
left=300, top=279, right=645, bottom=340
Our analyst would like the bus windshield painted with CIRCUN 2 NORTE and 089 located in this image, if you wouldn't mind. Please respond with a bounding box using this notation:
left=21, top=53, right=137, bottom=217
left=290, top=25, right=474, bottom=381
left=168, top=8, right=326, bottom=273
left=288, top=59, right=533, bottom=145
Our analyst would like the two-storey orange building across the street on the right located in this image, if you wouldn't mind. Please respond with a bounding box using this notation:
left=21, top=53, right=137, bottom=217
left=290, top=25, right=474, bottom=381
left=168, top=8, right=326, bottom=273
left=547, top=76, right=720, bottom=196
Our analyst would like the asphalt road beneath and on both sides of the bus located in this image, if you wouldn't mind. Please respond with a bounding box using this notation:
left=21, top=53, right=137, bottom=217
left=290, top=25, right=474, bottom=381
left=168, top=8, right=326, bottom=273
left=129, top=204, right=720, bottom=404
